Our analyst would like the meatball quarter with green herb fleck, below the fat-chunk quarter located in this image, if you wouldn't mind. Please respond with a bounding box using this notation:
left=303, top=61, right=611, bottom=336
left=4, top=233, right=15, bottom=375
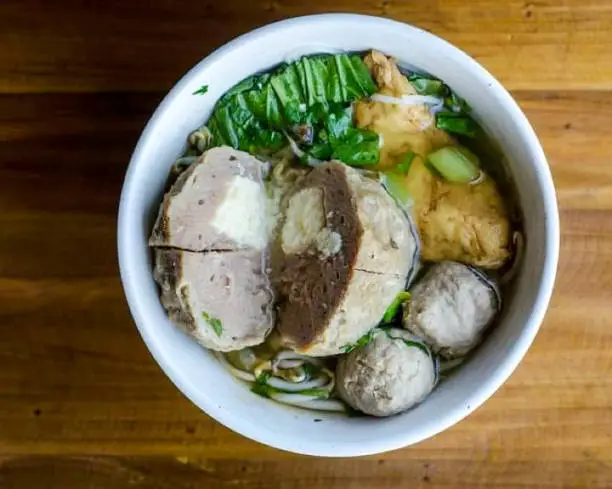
left=154, top=248, right=274, bottom=351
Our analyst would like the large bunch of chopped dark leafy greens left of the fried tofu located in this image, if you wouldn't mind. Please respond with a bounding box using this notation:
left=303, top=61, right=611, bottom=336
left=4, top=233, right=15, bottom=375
left=198, top=54, right=379, bottom=165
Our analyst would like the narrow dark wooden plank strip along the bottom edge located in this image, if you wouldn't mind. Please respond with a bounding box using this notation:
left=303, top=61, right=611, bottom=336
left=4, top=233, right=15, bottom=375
left=0, top=457, right=612, bottom=489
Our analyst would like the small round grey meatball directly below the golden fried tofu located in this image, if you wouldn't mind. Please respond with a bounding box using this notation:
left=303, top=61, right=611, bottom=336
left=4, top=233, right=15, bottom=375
left=403, top=261, right=501, bottom=358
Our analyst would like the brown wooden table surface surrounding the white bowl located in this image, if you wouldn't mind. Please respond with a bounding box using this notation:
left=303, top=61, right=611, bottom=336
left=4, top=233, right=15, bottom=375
left=0, top=0, right=612, bottom=489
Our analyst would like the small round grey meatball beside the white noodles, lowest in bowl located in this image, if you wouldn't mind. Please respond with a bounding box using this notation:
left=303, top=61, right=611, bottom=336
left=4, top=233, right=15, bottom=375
left=336, top=329, right=437, bottom=416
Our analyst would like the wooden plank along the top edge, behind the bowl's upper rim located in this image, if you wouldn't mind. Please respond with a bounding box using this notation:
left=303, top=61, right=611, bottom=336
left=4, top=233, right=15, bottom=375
left=0, top=0, right=612, bottom=93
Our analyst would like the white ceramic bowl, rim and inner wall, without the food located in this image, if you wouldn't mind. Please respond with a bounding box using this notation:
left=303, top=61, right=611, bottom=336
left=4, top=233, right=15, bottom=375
left=118, top=14, right=559, bottom=456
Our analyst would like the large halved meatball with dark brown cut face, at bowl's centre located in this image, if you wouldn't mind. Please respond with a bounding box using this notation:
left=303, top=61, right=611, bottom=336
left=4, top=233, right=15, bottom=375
left=273, top=162, right=418, bottom=356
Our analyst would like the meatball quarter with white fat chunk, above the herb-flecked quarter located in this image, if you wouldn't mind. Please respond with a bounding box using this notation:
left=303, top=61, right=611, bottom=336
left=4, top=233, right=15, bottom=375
left=149, top=147, right=268, bottom=251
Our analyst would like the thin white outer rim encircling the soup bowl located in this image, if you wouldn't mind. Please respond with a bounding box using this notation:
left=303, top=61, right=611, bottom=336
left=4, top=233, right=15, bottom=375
left=117, top=13, right=560, bottom=457
